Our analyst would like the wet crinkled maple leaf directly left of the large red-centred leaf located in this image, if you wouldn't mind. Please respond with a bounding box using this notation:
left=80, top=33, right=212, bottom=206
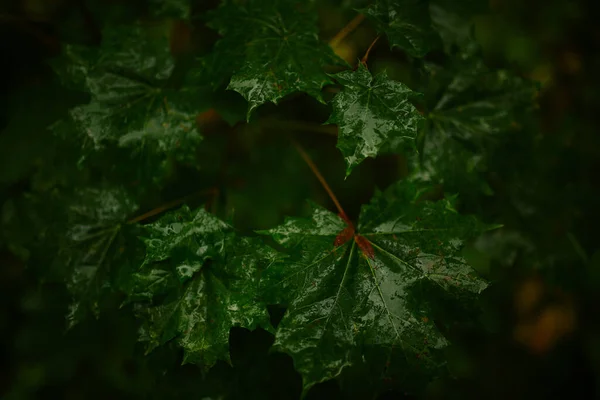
left=122, top=207, right=278, bottom=368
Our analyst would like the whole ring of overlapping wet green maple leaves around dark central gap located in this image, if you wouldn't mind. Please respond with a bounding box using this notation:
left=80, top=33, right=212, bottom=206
left=2, top=0, right=534, bottom=396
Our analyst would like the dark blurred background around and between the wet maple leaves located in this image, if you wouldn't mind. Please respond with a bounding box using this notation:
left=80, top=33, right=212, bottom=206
left=0, top=0, right=600, bottom=399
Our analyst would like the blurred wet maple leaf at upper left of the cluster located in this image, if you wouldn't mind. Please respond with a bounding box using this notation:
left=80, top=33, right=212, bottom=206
left=53, top=23, right=208, bottom=166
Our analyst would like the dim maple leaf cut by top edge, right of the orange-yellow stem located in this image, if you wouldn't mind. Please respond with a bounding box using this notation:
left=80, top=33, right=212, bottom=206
left=361, top=0, right=439, bottom=57
